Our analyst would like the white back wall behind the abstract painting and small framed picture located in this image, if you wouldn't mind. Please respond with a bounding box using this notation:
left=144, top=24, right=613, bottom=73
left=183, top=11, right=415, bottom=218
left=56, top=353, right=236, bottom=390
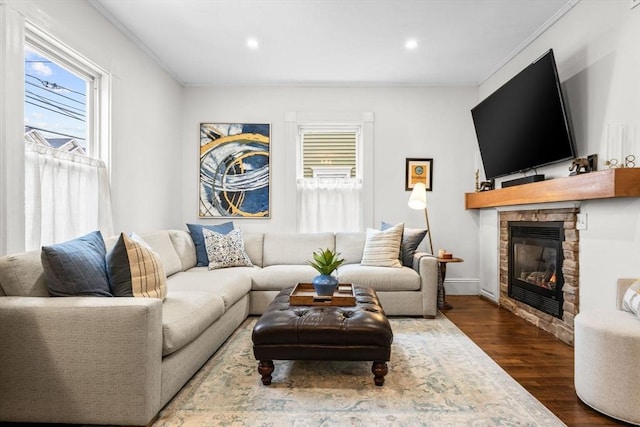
left=182, top=87, right=478, bottom=293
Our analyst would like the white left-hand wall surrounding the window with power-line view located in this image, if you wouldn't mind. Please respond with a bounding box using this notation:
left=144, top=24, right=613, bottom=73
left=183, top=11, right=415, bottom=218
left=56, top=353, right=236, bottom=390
left=0, top=0, right=182, bottom=253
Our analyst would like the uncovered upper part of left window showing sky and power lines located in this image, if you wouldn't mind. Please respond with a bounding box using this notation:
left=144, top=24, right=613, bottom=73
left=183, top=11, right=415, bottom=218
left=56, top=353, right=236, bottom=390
left=24, top=25, right=110, bottom=160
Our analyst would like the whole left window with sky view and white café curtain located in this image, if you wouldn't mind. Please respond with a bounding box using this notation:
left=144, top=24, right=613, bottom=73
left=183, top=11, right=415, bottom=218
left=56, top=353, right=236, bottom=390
left=24, top=25, right=113, bottom=250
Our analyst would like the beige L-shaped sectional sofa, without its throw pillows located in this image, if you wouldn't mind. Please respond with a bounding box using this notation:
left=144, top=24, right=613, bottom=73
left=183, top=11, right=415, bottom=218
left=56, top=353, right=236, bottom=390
left=0, top=230, right=437, bottom=425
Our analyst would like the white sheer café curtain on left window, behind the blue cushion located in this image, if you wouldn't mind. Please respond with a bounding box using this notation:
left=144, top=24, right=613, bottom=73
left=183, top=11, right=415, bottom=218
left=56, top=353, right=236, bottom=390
left=25, top=142, right=113, bottom=250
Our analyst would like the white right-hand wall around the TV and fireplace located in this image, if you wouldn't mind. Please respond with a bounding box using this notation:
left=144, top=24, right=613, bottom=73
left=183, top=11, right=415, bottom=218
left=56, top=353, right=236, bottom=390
left=479, top=0, right=640, bottom=311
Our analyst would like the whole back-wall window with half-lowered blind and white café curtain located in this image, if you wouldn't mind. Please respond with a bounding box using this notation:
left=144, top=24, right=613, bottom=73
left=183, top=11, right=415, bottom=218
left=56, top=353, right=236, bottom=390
left=298, top=124, right=362, bottom=232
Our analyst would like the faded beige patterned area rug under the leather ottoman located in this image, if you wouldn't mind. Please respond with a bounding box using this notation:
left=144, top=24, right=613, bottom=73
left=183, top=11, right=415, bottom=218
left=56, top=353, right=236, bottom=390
left=154, top=314, right=564, bottom=427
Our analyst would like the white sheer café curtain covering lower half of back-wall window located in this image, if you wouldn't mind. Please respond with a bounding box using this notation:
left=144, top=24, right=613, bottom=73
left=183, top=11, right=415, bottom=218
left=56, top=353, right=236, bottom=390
left=297, top=179, right=362, bottom=233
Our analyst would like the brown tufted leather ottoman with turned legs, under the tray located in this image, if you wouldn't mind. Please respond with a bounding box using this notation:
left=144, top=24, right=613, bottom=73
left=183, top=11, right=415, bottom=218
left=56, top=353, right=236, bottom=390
left=252, top=286, right=393, bottom=386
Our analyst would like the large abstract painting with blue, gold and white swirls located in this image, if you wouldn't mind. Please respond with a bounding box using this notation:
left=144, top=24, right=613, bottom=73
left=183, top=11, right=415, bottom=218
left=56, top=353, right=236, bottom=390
left=198, top=122, right=271, bottom=219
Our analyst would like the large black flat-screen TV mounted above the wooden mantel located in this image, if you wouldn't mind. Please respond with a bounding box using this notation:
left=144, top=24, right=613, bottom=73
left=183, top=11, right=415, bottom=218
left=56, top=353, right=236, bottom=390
left=471, top=50, right=575, bottom=179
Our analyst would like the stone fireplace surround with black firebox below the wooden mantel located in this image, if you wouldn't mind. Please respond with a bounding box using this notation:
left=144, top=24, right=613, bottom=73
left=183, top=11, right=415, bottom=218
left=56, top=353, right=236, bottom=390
left=499, top=208, right=579, bottom=345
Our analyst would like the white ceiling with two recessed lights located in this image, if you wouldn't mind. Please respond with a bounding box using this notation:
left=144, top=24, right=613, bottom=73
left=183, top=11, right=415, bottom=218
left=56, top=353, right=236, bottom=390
left=91, top=0, right=578, bottom=86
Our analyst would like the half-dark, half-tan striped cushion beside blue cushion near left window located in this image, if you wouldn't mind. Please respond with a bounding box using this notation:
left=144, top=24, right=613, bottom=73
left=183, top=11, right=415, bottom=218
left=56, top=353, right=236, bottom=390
left=107, top=233, right=167, bottom=299
